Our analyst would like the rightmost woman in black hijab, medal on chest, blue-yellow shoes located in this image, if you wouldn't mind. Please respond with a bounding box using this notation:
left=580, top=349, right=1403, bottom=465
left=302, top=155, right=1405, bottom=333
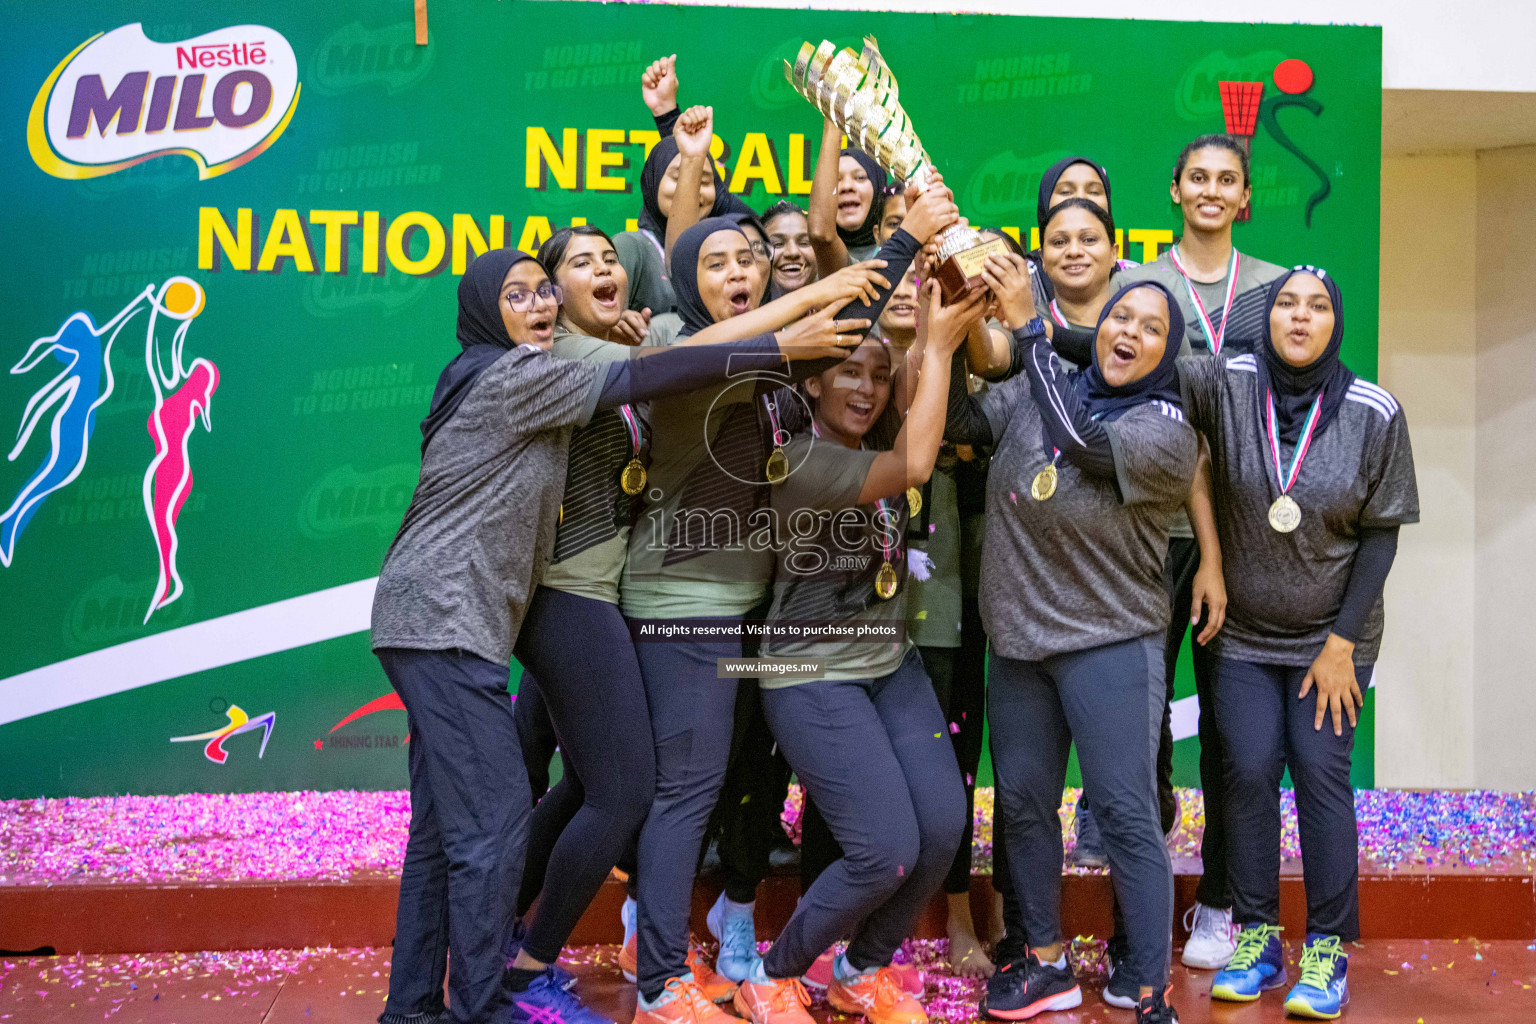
left=1180, top=267, right=1419, bottom=1018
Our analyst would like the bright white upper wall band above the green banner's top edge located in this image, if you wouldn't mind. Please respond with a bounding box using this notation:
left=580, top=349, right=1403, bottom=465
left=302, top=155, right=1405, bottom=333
left=632, top=0, right=1536, bottom=92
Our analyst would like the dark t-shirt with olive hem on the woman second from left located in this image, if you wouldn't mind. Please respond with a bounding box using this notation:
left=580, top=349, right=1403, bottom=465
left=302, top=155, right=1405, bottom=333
left=542, top=329, right=648, bottom=605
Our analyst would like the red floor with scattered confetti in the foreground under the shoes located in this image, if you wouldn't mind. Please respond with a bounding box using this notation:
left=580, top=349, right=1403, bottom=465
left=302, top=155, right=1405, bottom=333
left=0, top=941, right=1536, bottom=1024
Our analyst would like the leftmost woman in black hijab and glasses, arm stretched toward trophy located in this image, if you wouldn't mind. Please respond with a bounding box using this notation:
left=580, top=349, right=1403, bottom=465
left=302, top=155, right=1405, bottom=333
left=372, top=249, right=860, bottom=1024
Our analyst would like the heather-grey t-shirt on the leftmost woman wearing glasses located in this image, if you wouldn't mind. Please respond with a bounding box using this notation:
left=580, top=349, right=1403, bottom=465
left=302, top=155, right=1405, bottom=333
left=372, top=345, right=607, bottom=665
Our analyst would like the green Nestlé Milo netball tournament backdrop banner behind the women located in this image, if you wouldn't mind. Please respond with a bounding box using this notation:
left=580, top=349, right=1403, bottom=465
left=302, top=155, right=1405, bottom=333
left=0, top=0, right=1381, bottom=797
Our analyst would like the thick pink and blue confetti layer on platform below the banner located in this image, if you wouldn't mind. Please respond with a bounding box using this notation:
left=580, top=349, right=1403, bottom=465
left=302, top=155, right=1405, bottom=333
left=0, top=788, right=1536, bottom=884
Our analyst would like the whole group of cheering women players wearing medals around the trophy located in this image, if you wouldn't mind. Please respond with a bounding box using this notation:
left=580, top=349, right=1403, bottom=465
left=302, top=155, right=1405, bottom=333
left=372, top=58, right=1418, bottom=1024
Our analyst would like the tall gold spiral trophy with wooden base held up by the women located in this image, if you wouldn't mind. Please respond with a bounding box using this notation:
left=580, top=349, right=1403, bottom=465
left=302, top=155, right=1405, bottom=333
left=783, top=35, right=1008, bottom=304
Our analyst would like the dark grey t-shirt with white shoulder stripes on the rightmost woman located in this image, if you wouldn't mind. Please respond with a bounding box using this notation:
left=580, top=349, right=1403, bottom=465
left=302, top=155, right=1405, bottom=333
left=1180, top=353, right=1419, bottom=668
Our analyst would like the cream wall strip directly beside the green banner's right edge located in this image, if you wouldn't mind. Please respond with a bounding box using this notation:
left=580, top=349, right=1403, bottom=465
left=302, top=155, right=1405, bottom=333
left=1373, top=152, right=1478, bottom=788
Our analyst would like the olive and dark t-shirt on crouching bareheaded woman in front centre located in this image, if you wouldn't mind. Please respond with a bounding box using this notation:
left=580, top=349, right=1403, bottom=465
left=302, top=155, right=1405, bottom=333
left=759, top=434, right=911, bottom=689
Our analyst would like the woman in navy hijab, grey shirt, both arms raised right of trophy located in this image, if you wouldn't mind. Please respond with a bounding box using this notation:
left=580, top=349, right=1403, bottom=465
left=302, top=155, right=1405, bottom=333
left=945, top=256, right=1200, bottom=1024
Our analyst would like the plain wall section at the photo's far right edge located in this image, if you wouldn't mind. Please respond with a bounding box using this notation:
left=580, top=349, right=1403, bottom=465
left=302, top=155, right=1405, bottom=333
left=1473, top=146, right=1536, bottom=789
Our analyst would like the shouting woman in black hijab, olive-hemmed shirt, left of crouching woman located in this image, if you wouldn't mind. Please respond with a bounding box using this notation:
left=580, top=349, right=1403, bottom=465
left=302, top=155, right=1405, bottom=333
left=621, top=189, right=958, bottom=1024
